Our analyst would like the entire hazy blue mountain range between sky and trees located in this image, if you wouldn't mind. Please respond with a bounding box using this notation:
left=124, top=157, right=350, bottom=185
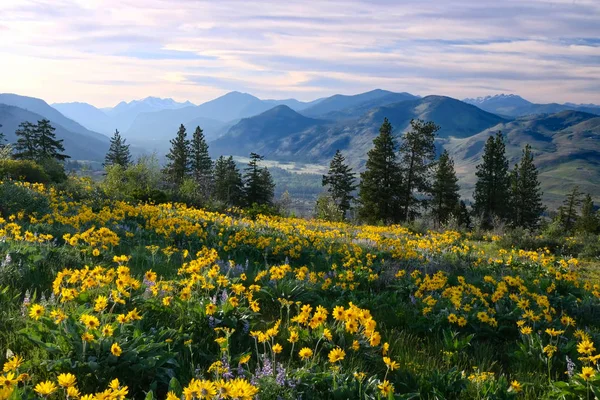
left=0, top=89, right=600, bottom=202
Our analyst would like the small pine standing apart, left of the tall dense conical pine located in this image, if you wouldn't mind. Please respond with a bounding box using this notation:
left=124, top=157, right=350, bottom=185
left=322, top=150, right=357, bottom=216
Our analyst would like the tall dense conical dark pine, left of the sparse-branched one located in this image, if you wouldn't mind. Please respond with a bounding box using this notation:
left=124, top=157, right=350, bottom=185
left=358, top=118, right=402, bottom=223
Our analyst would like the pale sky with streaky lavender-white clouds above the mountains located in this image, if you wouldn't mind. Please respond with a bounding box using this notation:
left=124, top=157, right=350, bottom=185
left=0, top=0, right=600, bottom=107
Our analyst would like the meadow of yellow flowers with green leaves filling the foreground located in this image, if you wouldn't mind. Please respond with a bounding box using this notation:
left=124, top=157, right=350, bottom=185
left=0, top=183, right=600, bottom=400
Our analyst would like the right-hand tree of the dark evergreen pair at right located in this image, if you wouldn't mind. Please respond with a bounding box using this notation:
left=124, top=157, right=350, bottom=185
left=509, top=144, right=544, bottom=229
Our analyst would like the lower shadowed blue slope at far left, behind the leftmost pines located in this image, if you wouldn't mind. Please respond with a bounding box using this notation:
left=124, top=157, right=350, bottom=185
left=0, top=104, right=109, bottom=161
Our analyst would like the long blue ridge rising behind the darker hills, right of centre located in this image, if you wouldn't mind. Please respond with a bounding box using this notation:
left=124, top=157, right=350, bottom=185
left=302, top=89, right=417, bottom=117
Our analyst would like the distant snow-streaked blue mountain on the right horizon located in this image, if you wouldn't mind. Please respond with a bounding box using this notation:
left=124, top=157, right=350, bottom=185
left=463, top=94, right=600, bottom=117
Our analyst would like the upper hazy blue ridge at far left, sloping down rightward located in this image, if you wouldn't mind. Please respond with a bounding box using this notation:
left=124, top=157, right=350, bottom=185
left=0, top=93, right=108, bottom=141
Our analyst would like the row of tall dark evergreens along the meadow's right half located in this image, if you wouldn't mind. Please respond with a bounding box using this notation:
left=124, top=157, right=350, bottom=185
left=317, top=118, right=600, bottom=231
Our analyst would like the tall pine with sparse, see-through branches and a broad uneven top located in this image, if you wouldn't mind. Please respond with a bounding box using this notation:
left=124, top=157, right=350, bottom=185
left=400, top=120, right=440, bottom=221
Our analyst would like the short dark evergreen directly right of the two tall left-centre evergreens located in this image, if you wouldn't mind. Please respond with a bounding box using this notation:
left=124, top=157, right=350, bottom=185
left=213, top=156, right=244, bottom=206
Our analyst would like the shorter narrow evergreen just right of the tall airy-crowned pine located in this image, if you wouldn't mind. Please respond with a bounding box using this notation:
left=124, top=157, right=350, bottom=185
left=431, top=150, right=460, bottom=226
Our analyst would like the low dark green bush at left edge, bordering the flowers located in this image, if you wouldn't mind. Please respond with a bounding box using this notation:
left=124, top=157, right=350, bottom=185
left=0, top=183, right=50, bottom=218
